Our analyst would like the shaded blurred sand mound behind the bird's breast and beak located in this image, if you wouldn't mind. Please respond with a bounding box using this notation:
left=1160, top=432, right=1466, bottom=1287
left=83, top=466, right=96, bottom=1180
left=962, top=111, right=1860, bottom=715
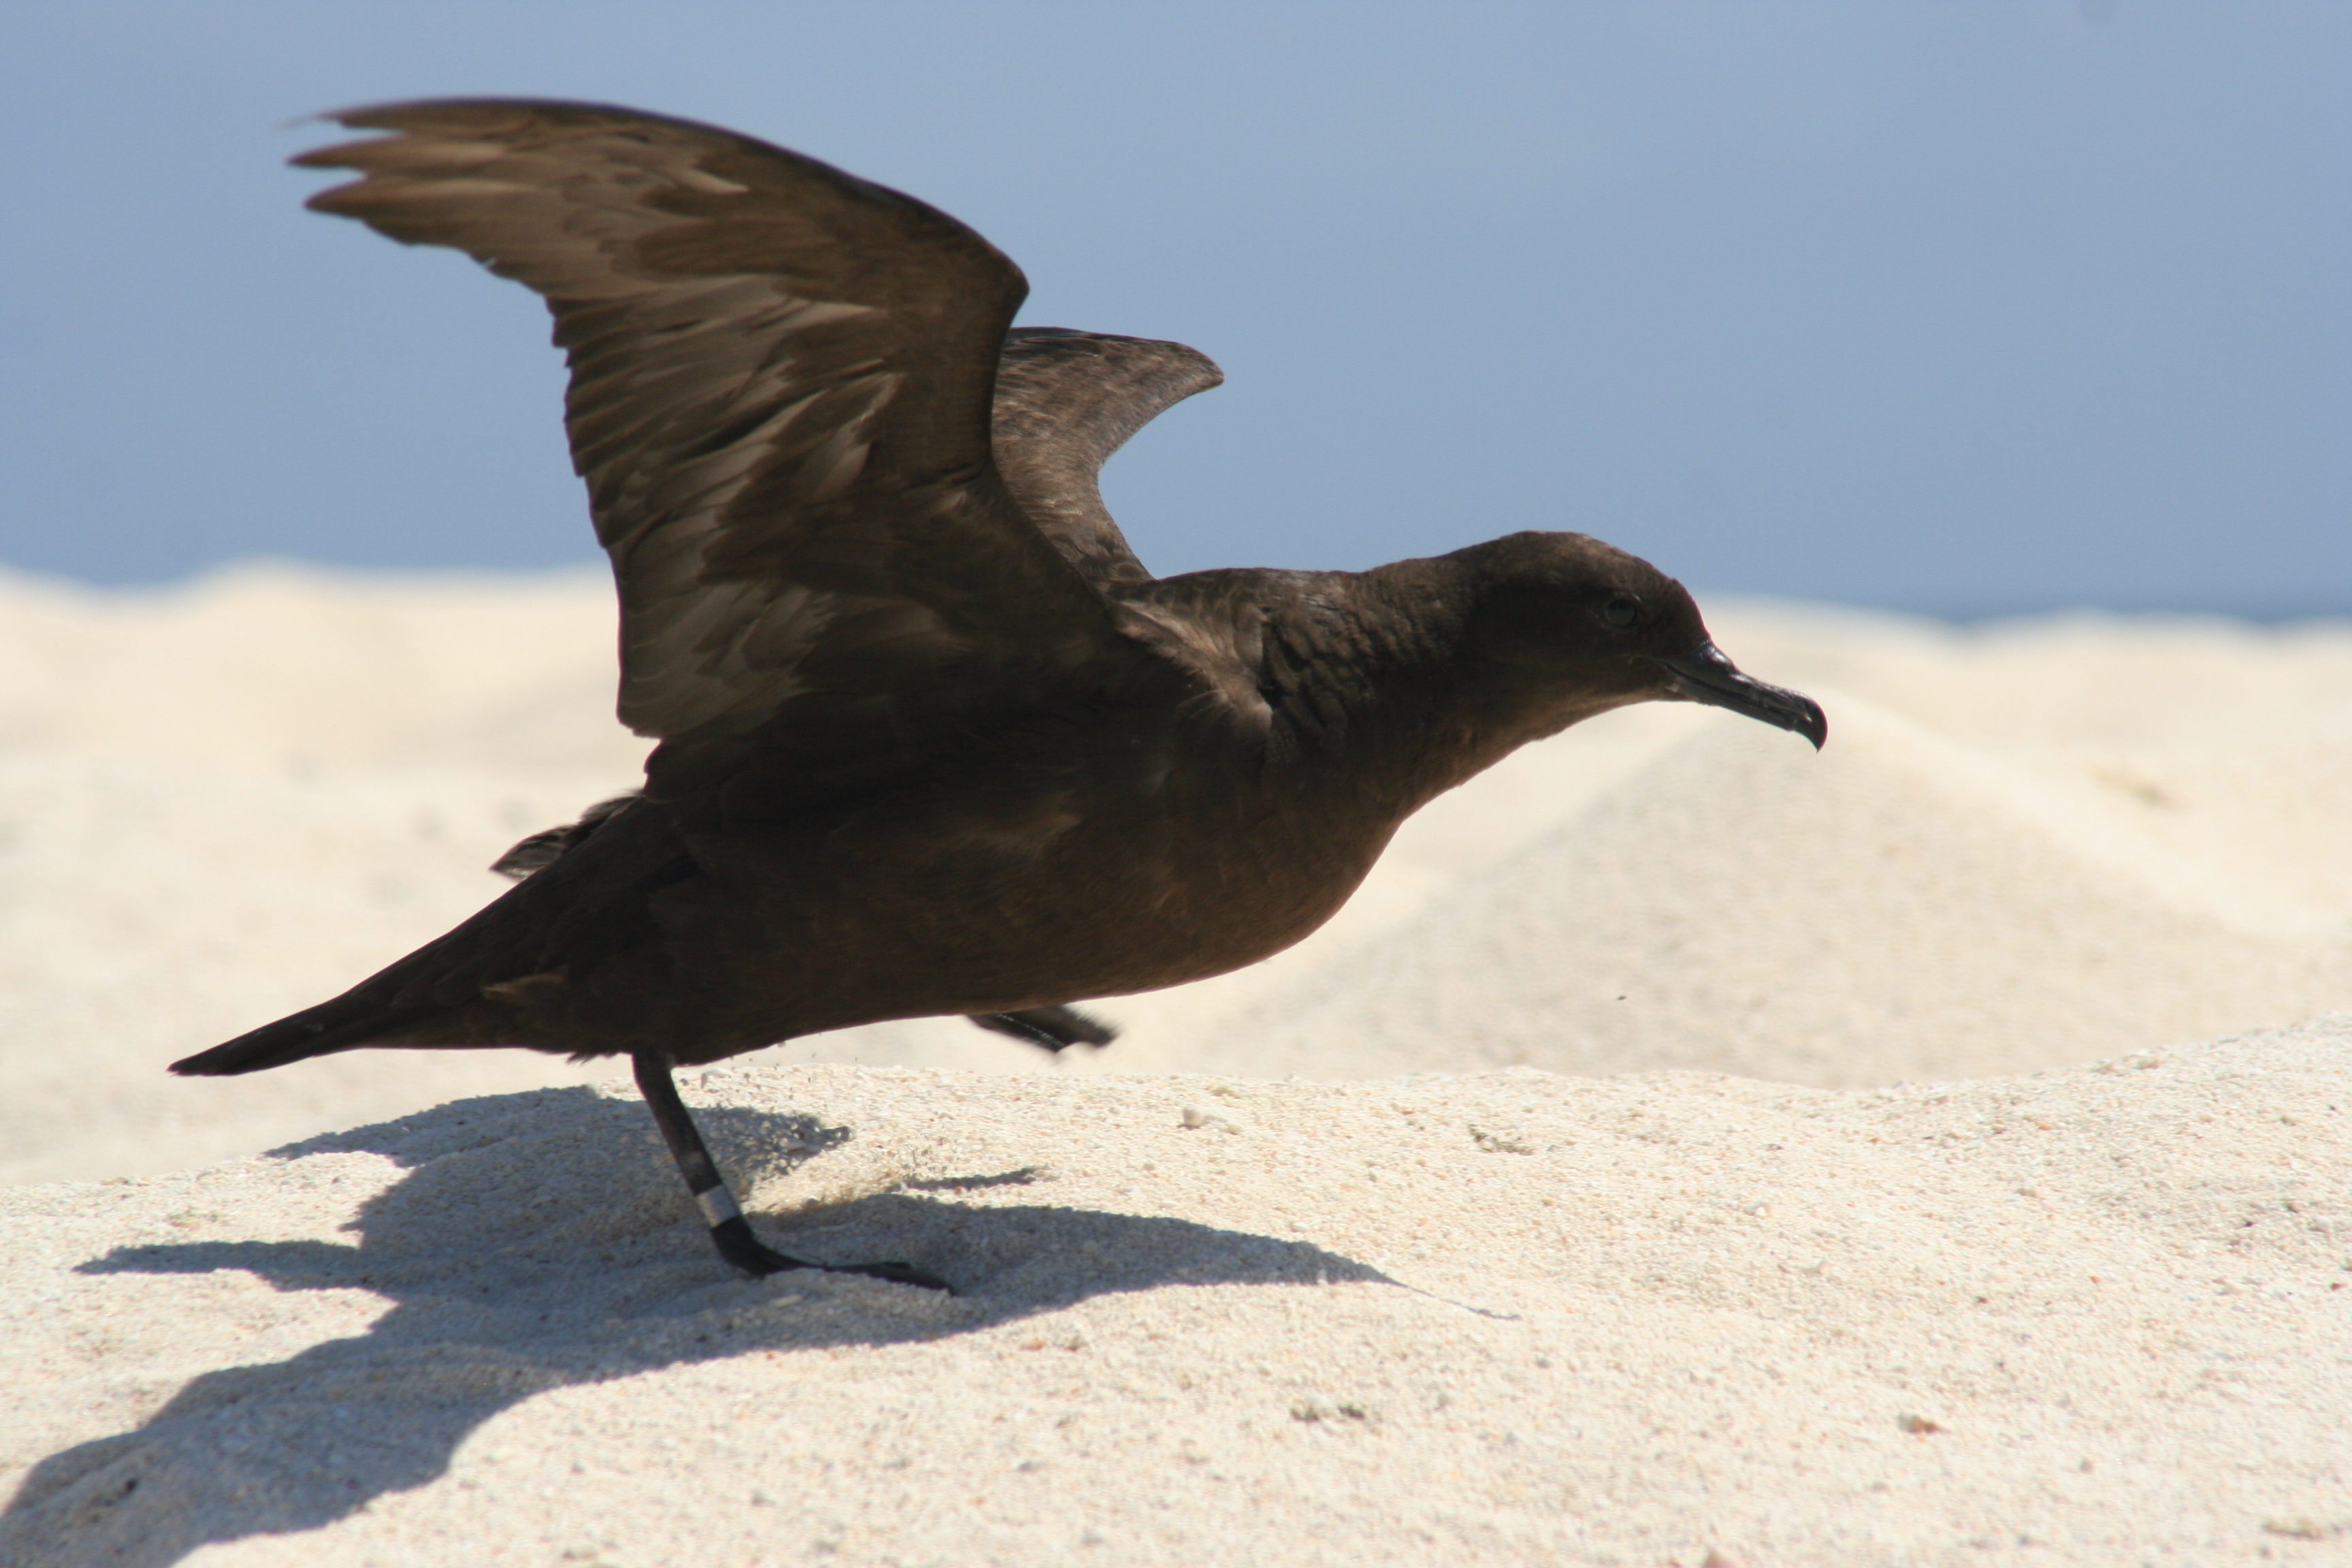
left=1211, top=698, right=2352, bottom=1086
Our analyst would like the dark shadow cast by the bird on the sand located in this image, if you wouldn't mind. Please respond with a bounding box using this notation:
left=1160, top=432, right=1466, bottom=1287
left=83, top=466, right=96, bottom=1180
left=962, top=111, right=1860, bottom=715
left=0, top=1088, right=1392, bottom=1568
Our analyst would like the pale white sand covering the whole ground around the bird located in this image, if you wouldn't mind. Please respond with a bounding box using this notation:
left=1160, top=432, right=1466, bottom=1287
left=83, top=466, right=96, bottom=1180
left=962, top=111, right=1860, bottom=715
left=0, top=569, right=2352, bottom=1568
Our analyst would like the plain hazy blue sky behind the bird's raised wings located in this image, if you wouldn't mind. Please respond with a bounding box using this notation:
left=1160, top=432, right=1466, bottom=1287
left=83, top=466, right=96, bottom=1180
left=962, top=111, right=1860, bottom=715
left=0, top=0, right=2352, bottom=616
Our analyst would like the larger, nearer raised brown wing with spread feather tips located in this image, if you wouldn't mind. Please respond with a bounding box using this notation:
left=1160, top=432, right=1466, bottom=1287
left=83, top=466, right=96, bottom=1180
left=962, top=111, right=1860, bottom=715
left=294, top=101, right=1139, bottom=795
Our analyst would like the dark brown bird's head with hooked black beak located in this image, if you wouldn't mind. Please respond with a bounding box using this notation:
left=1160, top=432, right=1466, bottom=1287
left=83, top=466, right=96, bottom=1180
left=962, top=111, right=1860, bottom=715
left=1444, top=534, right=1827, bottom=747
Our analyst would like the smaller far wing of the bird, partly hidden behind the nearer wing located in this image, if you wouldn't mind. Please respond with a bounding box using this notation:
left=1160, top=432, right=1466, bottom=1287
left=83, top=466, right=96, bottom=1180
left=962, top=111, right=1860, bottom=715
left=995, top=327, right=1226, bottom=592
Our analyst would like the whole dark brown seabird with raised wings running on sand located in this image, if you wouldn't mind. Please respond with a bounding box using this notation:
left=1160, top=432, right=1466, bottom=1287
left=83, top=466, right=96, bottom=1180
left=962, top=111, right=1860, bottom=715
left=172, top=99, right=1827, bottom=1288
